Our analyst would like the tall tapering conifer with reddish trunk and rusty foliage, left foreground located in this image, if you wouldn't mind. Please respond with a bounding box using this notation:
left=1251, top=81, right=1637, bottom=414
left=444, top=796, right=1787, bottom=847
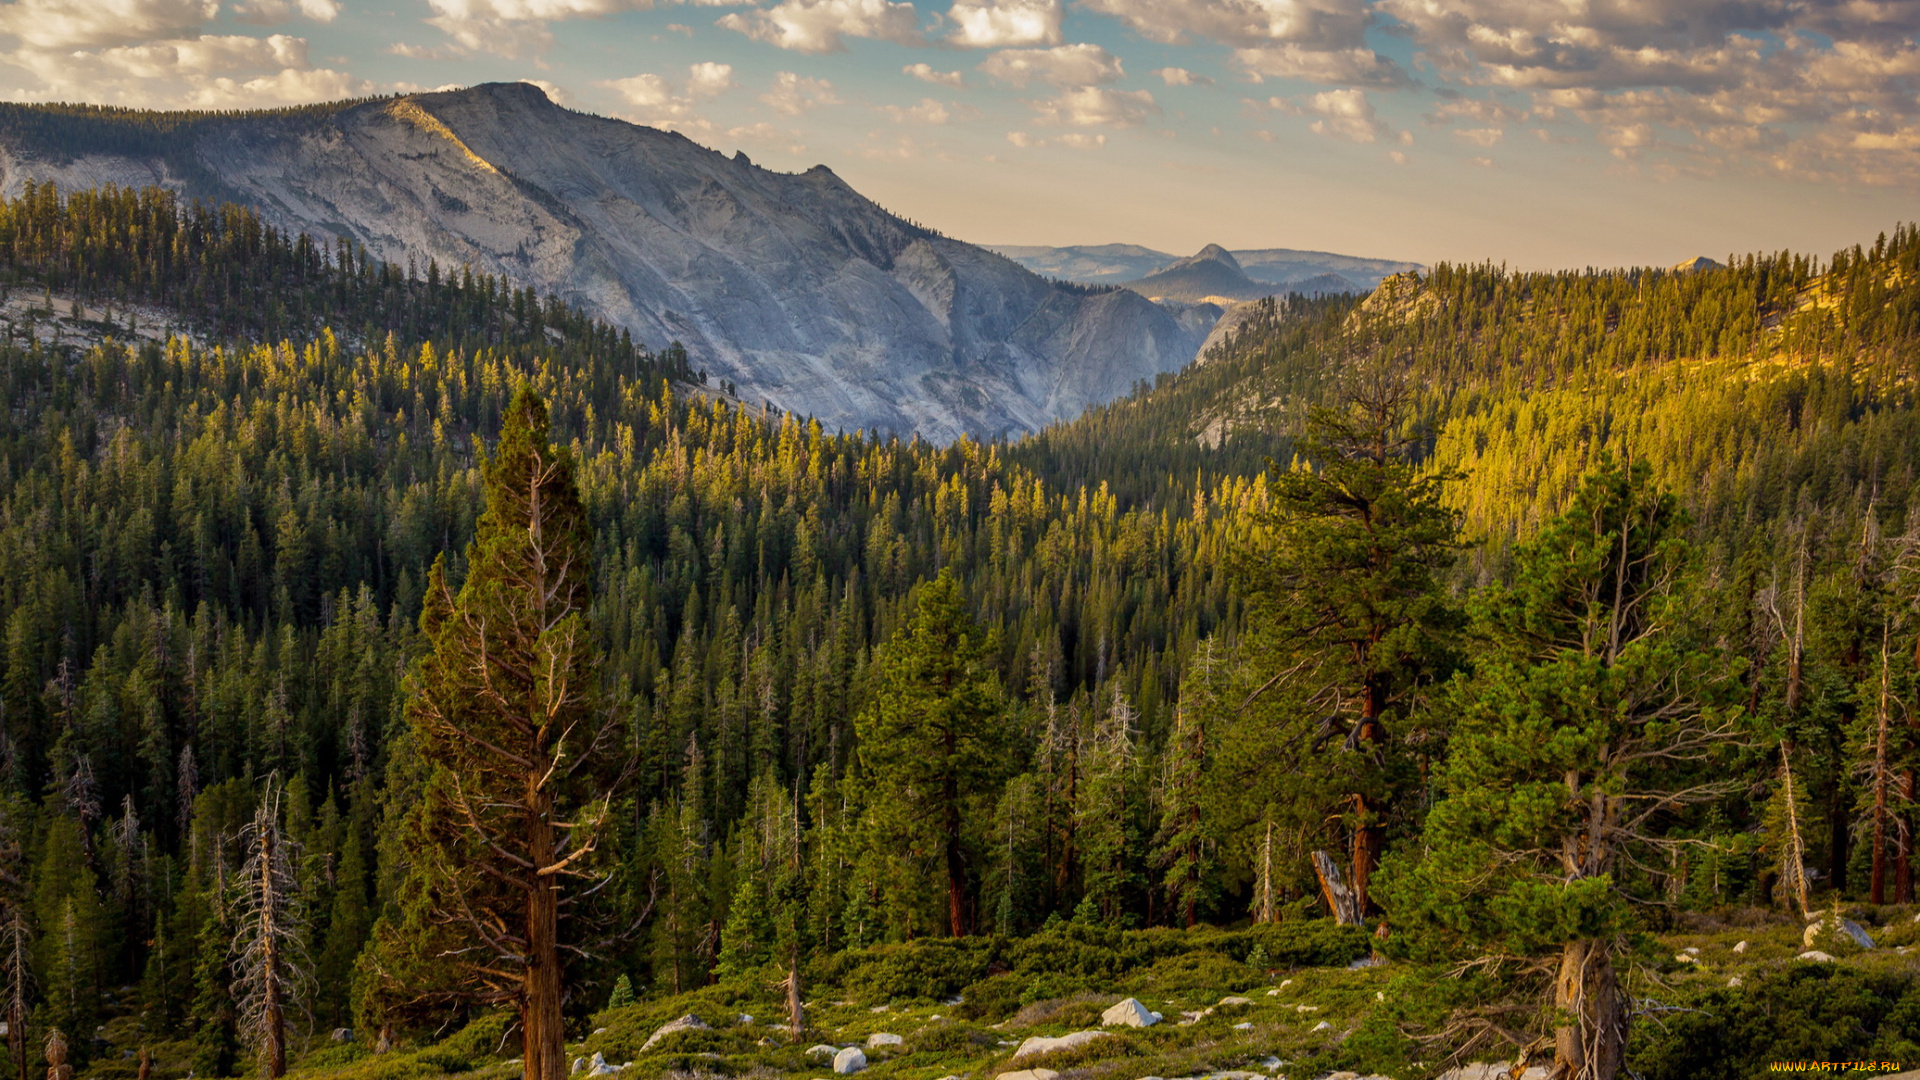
left=407, top=388, right=620, bottom=1080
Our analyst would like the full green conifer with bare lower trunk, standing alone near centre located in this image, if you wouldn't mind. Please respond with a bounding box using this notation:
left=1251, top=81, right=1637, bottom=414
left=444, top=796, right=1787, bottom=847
left=854, top=569, right=1006, bottom=938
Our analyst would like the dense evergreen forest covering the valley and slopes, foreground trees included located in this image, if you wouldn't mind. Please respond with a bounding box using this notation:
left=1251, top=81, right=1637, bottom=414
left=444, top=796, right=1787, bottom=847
left=0, top=186, right=1920, bottom=1080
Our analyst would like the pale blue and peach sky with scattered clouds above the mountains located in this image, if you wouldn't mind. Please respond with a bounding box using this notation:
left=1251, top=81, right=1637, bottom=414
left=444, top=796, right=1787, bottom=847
left=0, top=0, right=1920, bottom=269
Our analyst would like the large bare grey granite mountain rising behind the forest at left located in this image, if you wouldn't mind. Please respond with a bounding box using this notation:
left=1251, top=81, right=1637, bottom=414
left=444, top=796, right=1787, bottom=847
left=0, top=83, right=1210, bottom=442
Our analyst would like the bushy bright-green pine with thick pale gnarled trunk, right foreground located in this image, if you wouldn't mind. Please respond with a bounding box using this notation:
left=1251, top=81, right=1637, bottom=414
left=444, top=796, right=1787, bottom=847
left=1388, top=459, right=1743, bottom=1080
